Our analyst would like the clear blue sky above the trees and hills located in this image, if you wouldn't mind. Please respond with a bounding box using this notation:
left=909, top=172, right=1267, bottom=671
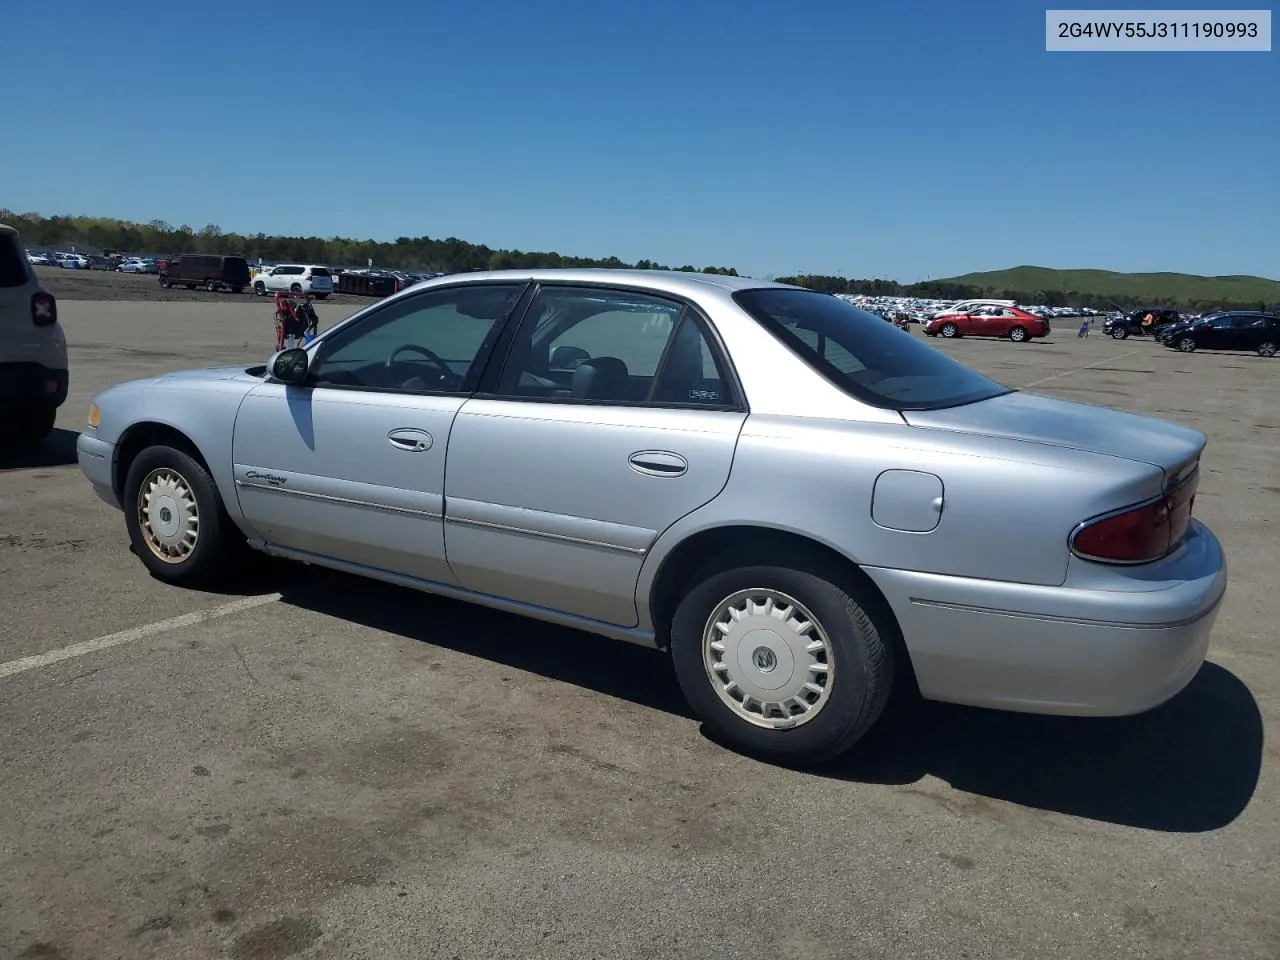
left=0, top=0, right=1280, bottom=282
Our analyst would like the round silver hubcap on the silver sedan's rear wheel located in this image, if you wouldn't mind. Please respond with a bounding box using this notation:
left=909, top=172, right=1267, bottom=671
left=703, top=589, right=835, bottom=730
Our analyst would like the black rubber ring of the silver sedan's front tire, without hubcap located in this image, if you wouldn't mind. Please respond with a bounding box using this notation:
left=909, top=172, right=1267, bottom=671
left=123, top=445, right=246, bottom=588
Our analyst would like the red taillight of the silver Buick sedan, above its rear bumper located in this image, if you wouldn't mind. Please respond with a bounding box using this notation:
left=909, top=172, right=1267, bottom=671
left=1071, top=472, right=1199, bottom=563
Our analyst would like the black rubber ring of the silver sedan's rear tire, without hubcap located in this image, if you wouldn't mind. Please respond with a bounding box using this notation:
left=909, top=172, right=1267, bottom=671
left=671, top=553, right=896, bottom=764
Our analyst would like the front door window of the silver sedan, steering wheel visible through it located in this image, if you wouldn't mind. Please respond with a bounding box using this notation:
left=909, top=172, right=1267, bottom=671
left=308, top=283, right=524, bottom=393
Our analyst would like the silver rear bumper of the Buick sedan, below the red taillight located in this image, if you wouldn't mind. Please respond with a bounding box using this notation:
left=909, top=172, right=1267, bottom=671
left=865, top=521, right=1228, bottom=717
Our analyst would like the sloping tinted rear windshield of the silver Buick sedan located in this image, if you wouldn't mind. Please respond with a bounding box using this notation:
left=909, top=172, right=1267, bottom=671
left=733, top=289, right=1012, bottom=410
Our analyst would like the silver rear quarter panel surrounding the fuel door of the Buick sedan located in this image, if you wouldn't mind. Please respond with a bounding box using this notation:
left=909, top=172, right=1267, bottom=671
left=639, top=415, right=1164, bottom=632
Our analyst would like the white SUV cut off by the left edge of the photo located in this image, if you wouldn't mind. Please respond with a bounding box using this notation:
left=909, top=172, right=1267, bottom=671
left=0, top=223, right=67, bottom=444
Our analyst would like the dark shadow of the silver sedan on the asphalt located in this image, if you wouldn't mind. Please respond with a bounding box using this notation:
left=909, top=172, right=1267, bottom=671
left=275, top=568, right=1263, bottom=833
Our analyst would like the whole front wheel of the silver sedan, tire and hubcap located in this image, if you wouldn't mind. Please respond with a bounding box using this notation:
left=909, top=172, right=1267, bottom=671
left=124, top=445, right=243, bottom=586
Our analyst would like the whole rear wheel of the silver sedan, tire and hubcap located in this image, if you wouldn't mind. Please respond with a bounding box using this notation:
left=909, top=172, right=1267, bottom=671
left=671, top=558, right=893, bottom=763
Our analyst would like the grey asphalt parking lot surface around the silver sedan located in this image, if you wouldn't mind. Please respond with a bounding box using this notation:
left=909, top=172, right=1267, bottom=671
left=0, top=271, right=1280, bottom=960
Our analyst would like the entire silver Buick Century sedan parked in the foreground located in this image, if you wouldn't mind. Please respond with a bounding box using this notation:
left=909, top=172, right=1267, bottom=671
left=78, top=270, right=1226, bottom=762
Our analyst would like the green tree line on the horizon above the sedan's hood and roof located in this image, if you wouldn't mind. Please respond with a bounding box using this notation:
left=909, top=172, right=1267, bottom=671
left=0, top=209, right=737, bottom=276
